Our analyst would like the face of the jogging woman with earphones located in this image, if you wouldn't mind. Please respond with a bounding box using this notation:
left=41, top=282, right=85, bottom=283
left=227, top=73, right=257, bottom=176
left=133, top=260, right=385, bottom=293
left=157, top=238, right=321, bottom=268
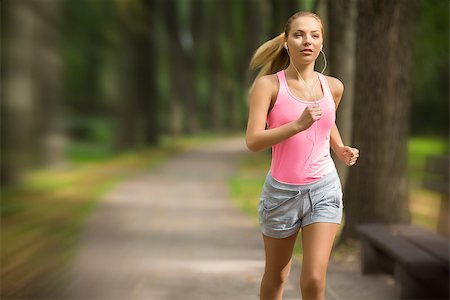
left=287, top=17, right=323, bottom=63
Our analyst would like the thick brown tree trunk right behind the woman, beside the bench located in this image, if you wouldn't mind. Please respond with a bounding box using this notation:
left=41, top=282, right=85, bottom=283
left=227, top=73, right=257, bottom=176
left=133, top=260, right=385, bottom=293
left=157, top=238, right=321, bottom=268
left=340, top=0, right=416, bottom=242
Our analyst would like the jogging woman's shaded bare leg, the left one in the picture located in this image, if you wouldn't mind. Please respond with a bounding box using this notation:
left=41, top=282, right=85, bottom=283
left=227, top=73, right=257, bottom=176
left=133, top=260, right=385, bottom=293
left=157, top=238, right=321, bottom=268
left=260, top=233, right=297, bottom=300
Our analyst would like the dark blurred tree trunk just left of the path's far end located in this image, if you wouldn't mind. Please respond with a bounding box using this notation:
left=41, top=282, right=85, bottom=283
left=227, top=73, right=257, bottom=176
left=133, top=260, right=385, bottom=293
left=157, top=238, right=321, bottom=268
left=116, top=0, right=159, bottom=150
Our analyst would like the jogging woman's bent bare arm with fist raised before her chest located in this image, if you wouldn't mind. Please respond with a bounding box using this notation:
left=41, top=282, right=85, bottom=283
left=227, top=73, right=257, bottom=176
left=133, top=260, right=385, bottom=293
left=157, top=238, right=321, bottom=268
left=246, top=76, right=321, bottom=152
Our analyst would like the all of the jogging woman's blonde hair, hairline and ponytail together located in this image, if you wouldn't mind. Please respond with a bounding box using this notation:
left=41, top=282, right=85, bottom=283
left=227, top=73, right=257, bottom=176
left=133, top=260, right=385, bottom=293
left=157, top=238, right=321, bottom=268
left=250, top=11, right=324, bottom=91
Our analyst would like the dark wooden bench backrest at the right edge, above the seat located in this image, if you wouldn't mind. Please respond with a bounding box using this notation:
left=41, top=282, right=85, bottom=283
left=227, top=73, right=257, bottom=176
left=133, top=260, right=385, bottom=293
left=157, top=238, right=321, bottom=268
left=423, top=156, right=450, bottom=237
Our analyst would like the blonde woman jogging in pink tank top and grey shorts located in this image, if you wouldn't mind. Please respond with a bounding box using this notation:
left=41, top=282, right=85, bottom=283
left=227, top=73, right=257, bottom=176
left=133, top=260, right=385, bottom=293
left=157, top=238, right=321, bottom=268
left=246, top=12, right=359, bottom=299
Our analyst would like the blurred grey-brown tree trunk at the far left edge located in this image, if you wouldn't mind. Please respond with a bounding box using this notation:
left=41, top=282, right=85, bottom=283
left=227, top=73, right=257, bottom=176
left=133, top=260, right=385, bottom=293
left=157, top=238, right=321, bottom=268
left=0, top=1, right=35, bottom=186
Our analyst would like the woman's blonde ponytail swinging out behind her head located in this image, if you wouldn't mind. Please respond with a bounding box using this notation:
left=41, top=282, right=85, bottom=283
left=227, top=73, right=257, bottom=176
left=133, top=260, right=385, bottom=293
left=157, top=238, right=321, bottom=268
left=250, top=32, right=289, bottom=91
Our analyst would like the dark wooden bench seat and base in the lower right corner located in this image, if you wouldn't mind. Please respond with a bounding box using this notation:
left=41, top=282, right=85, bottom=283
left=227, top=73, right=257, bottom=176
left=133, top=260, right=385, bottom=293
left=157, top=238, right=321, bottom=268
left=357, top=224, right=449, bottom=299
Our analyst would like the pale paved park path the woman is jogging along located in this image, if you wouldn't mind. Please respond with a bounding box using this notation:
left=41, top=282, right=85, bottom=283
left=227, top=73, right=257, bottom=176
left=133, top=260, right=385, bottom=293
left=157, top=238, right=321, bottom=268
left=63, top=138, right=393, bottom=300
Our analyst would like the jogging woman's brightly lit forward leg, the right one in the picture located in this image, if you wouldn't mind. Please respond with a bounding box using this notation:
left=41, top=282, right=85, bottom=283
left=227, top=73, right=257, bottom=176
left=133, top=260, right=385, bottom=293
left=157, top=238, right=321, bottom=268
left=300, top=222, right=339, bottom=300
